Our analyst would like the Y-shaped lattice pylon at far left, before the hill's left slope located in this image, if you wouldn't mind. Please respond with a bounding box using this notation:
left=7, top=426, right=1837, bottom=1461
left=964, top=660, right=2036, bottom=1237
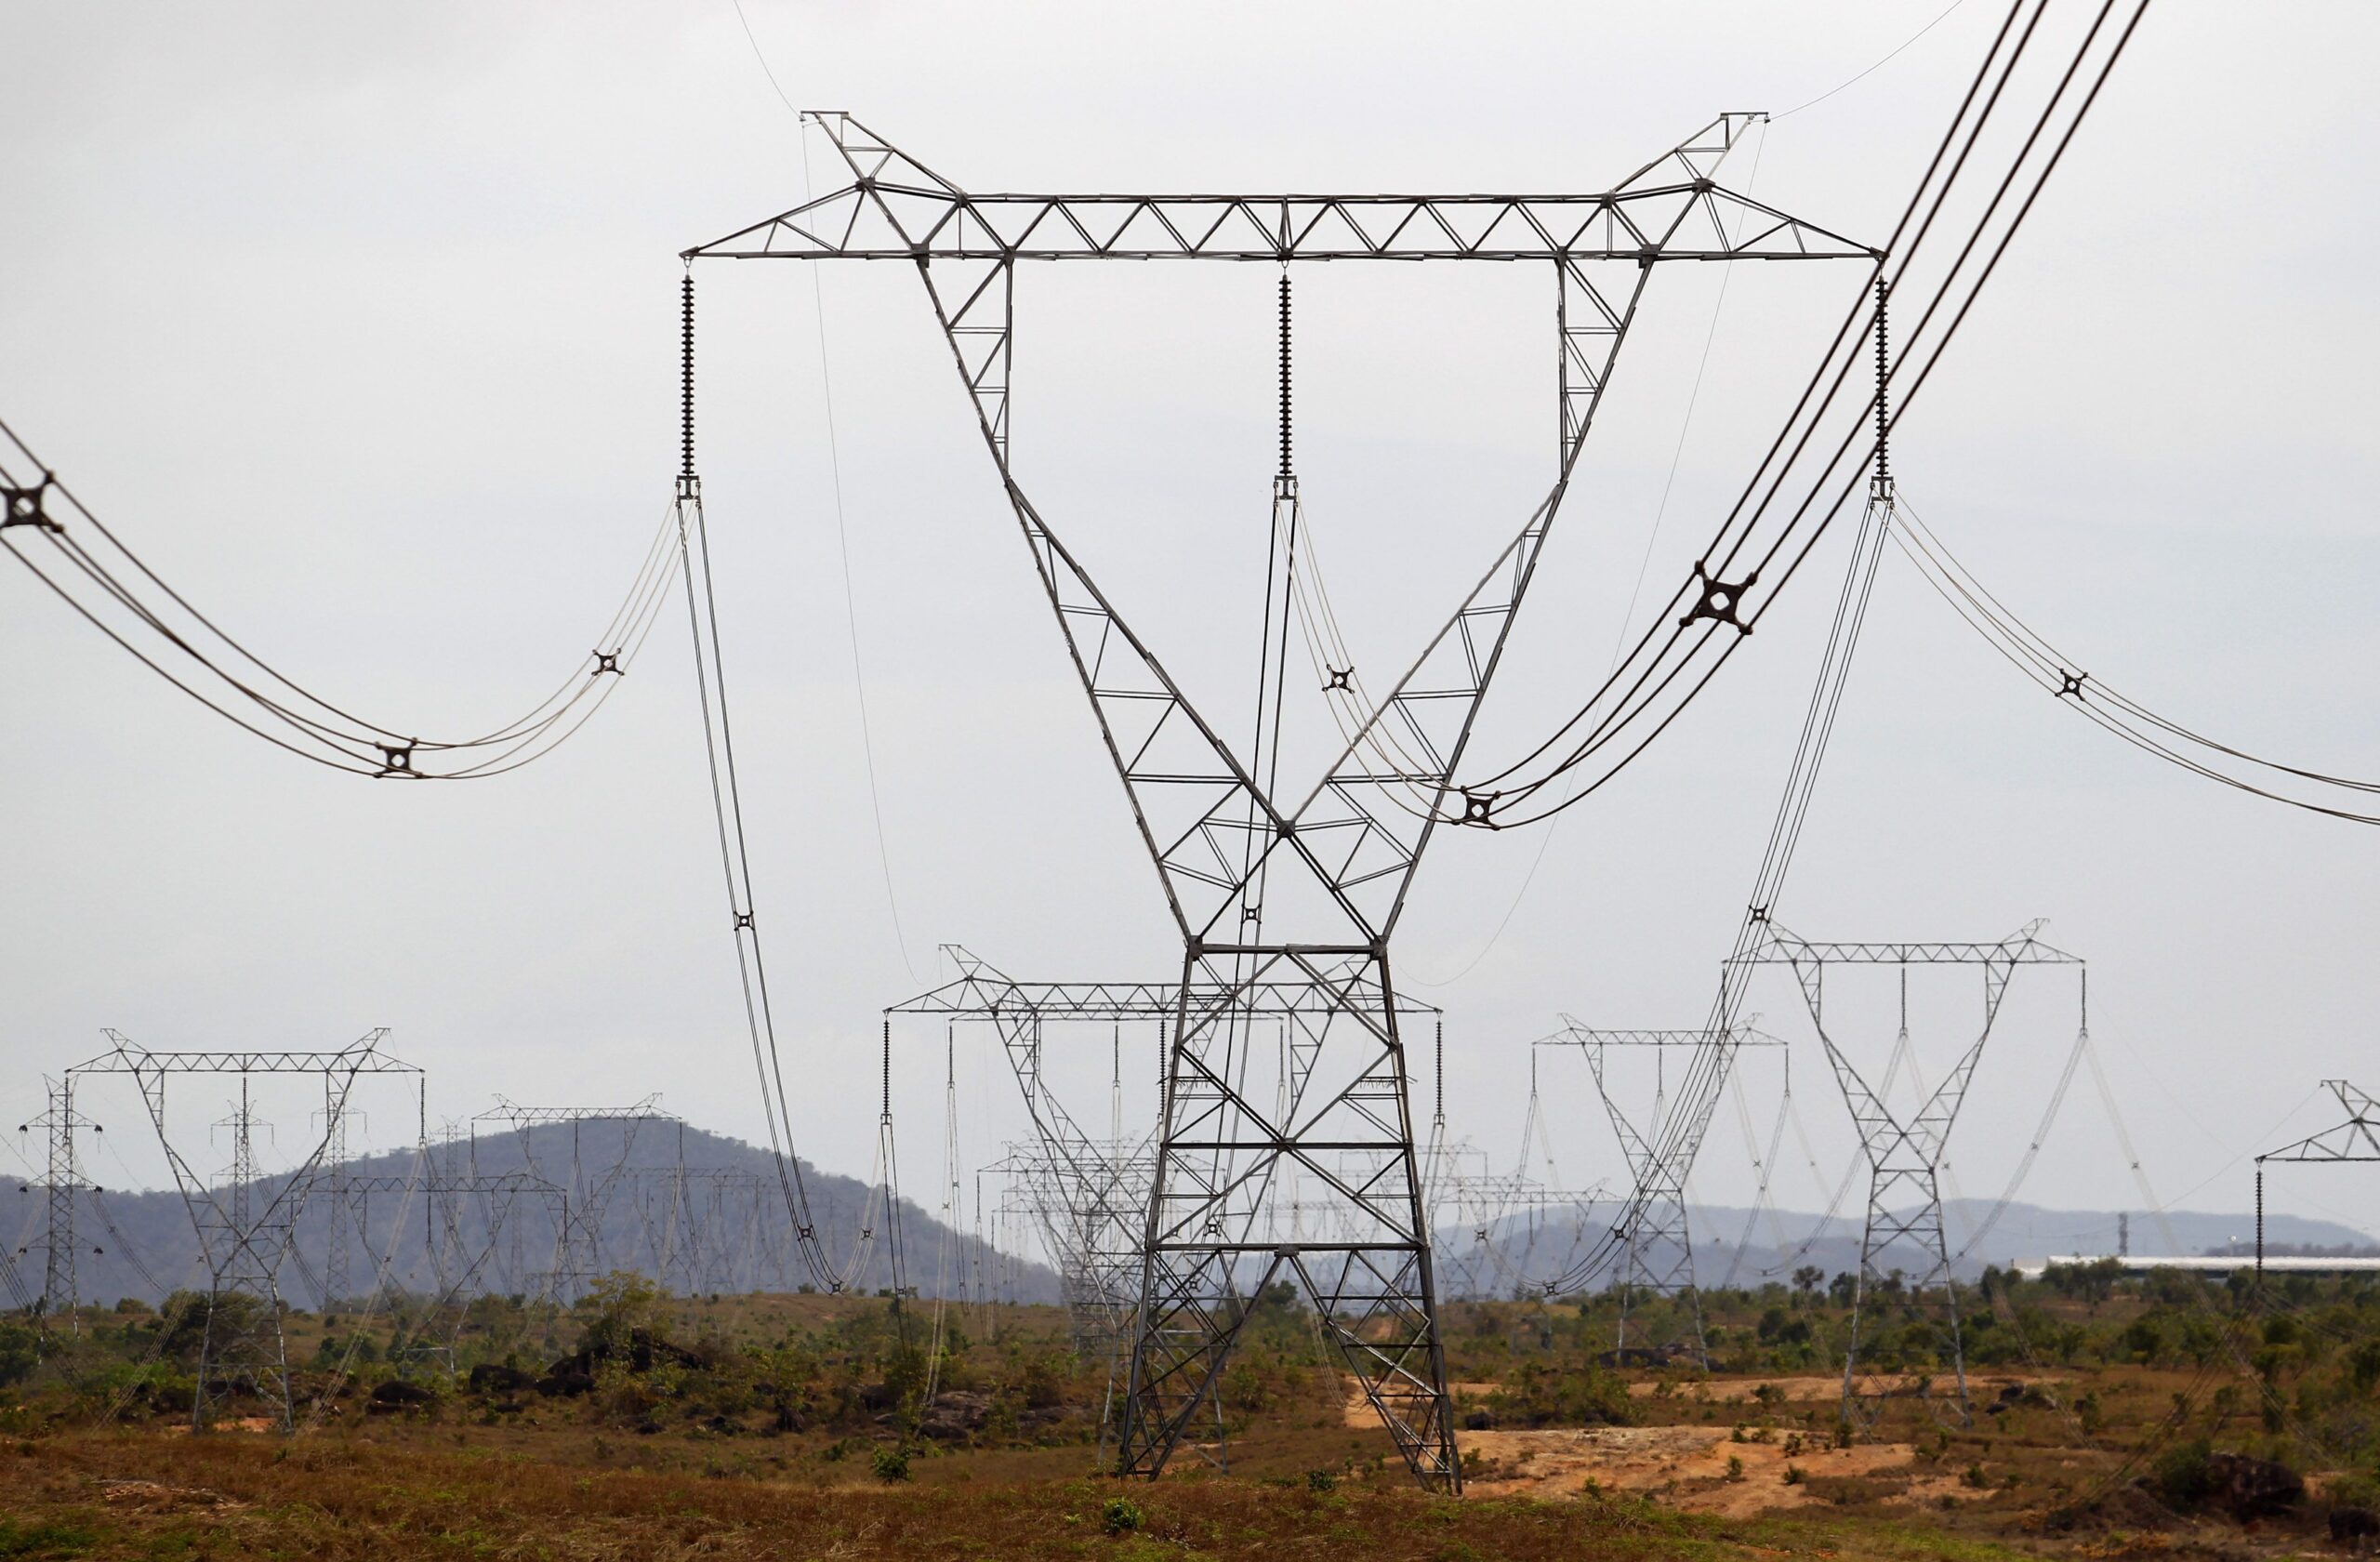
left=67, top=1028, right=421, bottom=1431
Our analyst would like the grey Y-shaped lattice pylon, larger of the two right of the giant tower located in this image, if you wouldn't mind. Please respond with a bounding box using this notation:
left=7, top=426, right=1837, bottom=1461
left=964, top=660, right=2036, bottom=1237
left=1739, top=920, right=2082, bottom=1426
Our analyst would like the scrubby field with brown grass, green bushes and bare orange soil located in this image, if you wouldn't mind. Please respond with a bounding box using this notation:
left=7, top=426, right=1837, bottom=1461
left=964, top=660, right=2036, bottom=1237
left=0, top=1269, right=2380, bottom=1562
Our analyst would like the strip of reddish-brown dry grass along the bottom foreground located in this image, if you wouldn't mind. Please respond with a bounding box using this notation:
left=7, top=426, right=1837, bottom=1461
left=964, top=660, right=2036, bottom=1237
left=0, top=1434, right=1818, bottom=1562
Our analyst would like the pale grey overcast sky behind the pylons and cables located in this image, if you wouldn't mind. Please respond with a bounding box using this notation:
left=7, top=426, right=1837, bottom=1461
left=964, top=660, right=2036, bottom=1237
left=0, top=0, right=2380, bottom=1245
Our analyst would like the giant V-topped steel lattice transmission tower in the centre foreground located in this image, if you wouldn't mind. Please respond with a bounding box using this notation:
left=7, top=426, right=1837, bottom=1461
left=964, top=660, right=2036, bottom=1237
left=685, top=112, right=1875, bottom=1490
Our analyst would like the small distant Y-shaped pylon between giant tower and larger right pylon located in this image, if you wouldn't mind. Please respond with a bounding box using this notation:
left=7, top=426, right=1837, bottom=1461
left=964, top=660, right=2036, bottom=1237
left=1538, top=1014, right=1785, bottom=1370
